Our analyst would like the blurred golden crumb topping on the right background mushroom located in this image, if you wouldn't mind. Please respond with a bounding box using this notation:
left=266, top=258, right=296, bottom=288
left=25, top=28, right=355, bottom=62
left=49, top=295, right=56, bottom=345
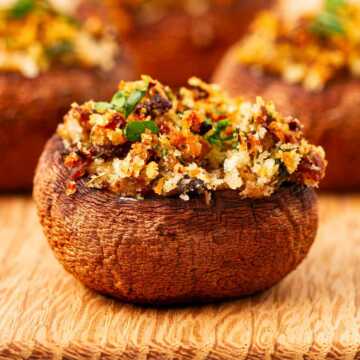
left=236, top=0, right=360, bottom=91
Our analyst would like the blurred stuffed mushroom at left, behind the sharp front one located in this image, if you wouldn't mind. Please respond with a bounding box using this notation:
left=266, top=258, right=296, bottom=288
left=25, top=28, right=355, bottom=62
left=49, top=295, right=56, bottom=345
left=0, top=0, right=133, bottom=191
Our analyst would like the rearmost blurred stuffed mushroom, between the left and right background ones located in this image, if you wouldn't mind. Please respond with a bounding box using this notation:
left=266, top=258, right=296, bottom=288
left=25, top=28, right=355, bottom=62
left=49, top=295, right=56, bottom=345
left=108, top=0, right=271, bottom=86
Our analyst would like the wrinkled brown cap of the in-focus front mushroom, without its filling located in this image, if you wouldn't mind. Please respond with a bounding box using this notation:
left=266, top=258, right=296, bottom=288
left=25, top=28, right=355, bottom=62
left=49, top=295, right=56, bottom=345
left=34, top=136, right=317, bottom=304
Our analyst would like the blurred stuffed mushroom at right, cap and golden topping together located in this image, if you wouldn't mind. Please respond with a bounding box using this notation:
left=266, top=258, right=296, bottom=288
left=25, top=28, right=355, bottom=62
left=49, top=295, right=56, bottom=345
left=214, top=0, right=360, bottom=190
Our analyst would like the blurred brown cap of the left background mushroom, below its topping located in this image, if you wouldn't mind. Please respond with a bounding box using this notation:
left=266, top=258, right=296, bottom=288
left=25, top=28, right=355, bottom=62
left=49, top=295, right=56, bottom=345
left=0, top=53, right=134, bottom=190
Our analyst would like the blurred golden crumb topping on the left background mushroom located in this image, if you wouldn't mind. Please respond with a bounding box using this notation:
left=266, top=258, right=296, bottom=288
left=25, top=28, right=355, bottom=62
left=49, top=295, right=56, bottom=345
left=0, top=0, right=118, bottom=78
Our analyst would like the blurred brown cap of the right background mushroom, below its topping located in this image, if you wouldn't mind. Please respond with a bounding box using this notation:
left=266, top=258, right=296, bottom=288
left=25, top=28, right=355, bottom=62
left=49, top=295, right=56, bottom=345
left=213, top=48, right=360, bottom=190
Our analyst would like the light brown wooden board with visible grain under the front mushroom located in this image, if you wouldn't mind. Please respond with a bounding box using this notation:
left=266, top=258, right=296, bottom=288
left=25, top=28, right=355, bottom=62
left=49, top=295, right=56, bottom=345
left=0, top=195, right=360, bottom=360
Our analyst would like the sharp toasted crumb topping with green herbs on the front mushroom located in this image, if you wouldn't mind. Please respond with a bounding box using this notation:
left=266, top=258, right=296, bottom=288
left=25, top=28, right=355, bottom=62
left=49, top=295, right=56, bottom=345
left=57, top=76, right=326, bottom=201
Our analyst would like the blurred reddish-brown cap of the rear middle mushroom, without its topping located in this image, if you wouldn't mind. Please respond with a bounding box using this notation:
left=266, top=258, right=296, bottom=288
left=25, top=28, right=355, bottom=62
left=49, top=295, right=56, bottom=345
left=108, top=0, right=272, bottom=86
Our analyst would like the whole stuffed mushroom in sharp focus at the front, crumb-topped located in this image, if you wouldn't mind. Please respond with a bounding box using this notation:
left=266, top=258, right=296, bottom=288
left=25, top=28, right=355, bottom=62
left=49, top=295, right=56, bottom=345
left=34, top=76, right=326, bottom=304
